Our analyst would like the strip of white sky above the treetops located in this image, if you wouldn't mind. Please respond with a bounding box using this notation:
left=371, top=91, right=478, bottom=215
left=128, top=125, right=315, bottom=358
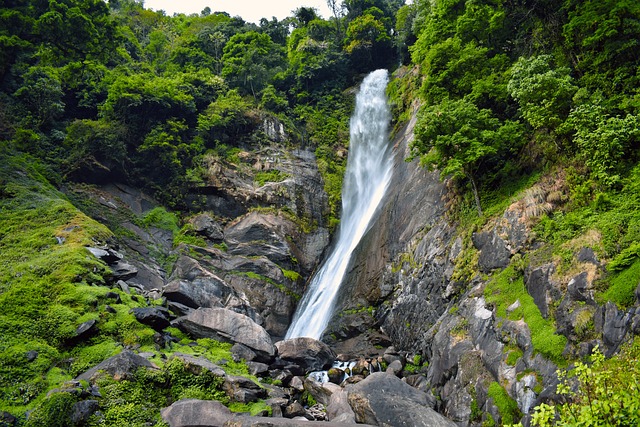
left=144, top=0, right=332, bottom=24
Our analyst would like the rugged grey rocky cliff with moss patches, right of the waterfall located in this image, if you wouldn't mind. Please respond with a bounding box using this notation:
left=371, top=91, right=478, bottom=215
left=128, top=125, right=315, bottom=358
left=323, top=104, right=640, bottom=426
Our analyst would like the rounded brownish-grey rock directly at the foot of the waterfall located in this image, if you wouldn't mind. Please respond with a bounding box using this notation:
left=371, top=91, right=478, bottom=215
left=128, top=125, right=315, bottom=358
left=276, top=337, right=336, bottom=372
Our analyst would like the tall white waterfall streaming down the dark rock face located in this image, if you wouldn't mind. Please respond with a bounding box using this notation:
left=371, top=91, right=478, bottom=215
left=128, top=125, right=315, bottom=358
left=285, top=70, right=392, bottom=339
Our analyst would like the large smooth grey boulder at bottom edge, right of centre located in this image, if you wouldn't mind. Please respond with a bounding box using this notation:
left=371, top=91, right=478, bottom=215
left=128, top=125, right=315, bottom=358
left=347, top=372, right=456, bottom=427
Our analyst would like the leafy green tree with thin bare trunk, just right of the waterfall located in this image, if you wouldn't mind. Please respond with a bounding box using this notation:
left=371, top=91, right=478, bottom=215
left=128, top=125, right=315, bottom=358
left=411, top=99, right=522, bottom=216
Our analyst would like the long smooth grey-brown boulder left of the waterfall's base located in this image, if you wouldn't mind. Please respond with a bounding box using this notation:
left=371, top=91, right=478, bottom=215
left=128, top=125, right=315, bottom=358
left=172, top=308, right=276, bottom=361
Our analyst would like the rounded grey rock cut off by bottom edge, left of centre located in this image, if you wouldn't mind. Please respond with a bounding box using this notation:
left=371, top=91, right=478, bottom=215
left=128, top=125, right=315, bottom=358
left=161, top=399, right=233, bottom=427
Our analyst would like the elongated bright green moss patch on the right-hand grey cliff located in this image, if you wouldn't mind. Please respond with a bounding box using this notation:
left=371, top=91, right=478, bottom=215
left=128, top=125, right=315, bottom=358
left=484, top=265, right=567, bottom=366
